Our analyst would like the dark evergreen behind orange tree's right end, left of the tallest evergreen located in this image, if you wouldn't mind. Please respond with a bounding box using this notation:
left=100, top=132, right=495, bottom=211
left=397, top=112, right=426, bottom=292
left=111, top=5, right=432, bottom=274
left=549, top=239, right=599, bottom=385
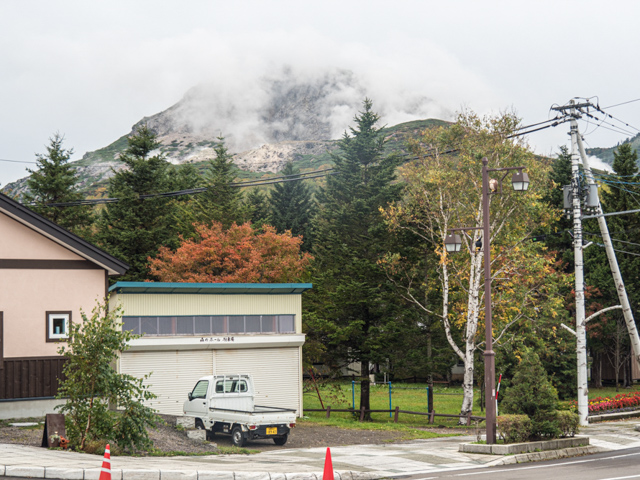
left=269, top=162, right=313, bottom=251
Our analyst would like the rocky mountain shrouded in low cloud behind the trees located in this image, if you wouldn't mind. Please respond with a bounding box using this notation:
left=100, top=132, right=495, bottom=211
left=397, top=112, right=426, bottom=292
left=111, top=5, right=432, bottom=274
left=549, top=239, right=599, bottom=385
left=3, top=69, right=446, bottom=198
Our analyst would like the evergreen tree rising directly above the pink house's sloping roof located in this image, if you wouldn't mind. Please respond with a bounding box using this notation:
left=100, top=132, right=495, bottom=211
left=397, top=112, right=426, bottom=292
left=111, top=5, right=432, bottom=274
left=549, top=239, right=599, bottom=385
left=24, top=133, right=92, bottom=235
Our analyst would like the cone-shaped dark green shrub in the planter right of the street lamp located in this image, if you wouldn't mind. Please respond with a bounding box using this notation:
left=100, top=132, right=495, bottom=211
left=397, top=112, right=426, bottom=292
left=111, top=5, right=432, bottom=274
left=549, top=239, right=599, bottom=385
left=501, top=350, right=561, bottom=438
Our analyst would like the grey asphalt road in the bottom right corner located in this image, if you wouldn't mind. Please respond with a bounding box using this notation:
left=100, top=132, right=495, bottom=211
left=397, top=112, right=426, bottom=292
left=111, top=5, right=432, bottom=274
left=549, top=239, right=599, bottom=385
left=401, top=448, right=640, bottom=480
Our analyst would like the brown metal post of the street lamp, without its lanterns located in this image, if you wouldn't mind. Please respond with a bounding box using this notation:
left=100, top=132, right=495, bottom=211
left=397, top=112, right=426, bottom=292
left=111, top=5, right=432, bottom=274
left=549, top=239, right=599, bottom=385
left=482, top=157, right=496, bottom=445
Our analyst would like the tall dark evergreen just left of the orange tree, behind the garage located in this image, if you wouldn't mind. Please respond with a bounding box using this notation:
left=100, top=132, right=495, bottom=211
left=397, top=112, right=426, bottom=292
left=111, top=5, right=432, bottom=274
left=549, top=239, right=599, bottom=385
left=96, top=125, right=178, bottom=281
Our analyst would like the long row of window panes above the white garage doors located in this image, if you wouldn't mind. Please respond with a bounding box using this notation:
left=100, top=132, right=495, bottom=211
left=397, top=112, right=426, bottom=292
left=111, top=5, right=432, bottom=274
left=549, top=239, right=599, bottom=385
left=122, top=315, right=295, bottom=336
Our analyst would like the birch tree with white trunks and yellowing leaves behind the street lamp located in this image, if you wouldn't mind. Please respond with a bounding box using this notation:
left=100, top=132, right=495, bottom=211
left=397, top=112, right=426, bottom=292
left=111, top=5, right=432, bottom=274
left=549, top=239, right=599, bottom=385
left=383, top=113, right=562, bottom=423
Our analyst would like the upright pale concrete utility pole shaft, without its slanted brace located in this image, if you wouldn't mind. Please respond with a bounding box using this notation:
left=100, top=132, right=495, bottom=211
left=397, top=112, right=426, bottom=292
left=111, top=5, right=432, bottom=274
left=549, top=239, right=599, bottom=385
left=571, top=103, right=589, bottom=426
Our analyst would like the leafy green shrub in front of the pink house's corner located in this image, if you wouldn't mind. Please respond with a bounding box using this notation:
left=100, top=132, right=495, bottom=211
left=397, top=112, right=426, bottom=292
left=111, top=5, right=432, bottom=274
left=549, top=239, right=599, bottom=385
left=56, top=299, right=157, bottom=450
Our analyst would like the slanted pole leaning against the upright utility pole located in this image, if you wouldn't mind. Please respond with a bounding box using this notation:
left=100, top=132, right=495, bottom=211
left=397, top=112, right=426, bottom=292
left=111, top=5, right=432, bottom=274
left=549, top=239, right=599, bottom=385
left=576, top=132, right=640, bottom=366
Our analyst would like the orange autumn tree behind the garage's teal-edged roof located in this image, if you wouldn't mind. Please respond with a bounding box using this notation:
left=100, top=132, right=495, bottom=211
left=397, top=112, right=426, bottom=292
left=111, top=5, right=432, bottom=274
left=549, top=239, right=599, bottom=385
left=149, top=222, right=313, bottom=283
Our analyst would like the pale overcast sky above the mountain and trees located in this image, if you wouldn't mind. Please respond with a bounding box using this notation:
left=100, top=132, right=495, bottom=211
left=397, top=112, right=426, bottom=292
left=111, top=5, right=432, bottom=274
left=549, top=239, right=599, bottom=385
left=0, top=0, right=640, bottom=185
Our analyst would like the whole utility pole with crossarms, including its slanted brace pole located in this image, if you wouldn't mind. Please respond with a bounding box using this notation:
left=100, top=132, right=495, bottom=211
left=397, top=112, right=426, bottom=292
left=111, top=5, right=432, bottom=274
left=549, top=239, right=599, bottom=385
left=553, top=96, right=640, bottom=425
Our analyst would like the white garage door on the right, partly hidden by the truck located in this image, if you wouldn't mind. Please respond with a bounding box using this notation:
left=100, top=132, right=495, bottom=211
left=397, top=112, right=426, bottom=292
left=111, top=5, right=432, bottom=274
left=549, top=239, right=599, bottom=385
left=215, top=347, right=301, bottom=413
